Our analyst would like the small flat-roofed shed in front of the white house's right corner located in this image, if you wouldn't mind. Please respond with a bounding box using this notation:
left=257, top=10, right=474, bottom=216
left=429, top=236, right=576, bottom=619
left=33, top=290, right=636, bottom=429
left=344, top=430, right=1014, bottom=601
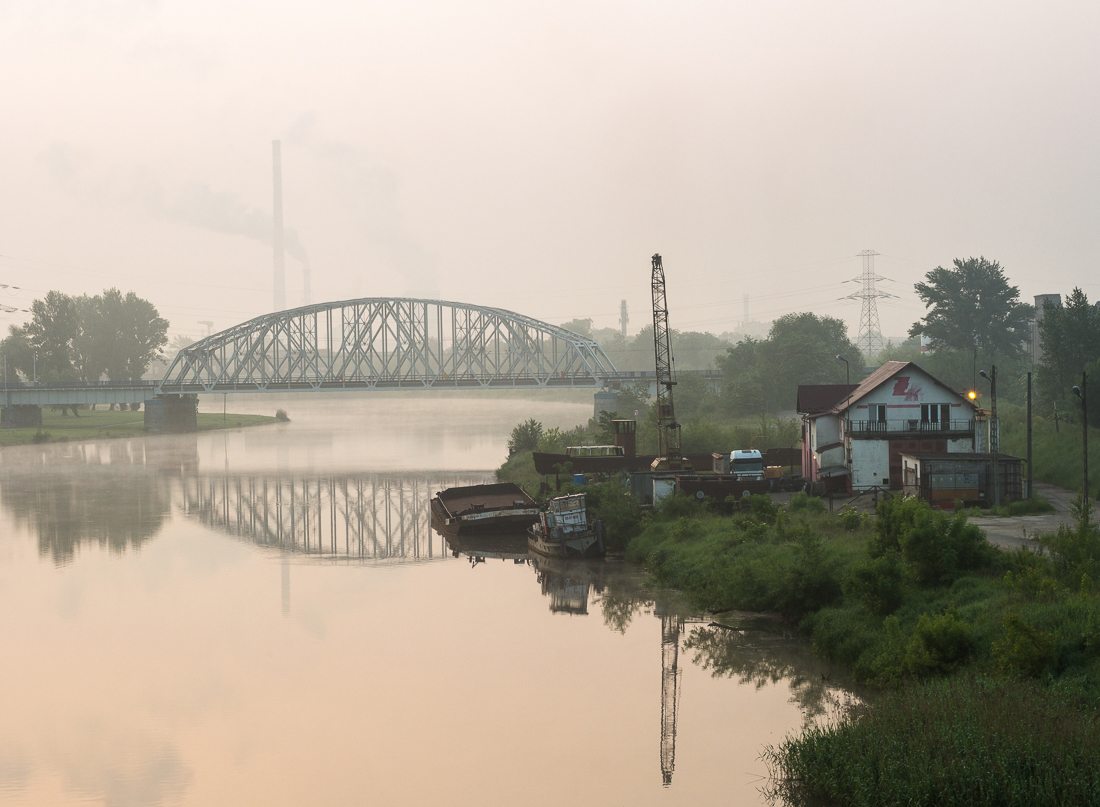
left=901, top=452, right=1023, bottom=509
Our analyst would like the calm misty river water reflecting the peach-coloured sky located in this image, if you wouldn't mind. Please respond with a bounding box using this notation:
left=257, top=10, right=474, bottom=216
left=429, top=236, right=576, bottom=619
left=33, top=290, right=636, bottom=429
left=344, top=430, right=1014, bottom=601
left=0, top=394, right=839, bottom=807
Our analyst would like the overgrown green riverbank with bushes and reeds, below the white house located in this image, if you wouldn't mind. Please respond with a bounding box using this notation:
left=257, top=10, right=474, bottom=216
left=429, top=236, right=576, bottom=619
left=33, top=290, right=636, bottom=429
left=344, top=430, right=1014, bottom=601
left=626, top=495, right=1100, bottom=806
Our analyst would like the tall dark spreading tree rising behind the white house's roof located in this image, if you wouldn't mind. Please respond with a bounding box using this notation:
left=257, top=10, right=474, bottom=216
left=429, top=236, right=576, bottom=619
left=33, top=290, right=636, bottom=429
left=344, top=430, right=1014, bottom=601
left=909, top=257, right=1034, bottom=361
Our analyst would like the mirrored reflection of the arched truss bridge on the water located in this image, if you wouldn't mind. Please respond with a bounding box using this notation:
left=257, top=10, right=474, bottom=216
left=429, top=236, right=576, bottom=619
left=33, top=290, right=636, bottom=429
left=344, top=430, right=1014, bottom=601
left=182, top=473, right=484, bottom=565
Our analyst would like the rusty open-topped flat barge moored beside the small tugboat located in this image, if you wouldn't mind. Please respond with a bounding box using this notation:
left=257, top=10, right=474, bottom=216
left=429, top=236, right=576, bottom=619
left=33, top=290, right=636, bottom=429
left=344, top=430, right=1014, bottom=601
left=431, top=482, right=539, bottom=535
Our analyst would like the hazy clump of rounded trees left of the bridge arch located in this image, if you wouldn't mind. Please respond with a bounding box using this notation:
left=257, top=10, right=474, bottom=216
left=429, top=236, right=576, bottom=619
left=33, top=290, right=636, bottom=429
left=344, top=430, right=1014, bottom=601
left=0, top=288, right=168, bottom=383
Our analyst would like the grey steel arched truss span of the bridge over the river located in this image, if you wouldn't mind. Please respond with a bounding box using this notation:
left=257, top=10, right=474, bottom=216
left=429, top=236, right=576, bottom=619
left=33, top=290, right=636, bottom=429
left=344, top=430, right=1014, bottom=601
left=156, top=298, right=619, bottom=395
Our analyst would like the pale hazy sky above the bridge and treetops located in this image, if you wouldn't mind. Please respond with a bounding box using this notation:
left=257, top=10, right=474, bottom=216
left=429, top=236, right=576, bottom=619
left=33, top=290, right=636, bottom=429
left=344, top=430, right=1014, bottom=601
left=0, top=0, right=1100, bottom=336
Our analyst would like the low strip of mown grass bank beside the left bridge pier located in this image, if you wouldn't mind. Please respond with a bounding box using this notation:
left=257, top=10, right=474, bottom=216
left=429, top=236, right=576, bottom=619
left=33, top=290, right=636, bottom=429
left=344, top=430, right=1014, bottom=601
left=0, top=409, right=276, bottom=446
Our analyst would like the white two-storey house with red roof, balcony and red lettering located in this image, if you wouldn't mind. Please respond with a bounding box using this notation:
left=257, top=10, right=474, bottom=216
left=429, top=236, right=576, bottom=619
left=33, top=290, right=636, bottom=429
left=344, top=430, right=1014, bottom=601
left=798, top=362, right=987, bottom=491
